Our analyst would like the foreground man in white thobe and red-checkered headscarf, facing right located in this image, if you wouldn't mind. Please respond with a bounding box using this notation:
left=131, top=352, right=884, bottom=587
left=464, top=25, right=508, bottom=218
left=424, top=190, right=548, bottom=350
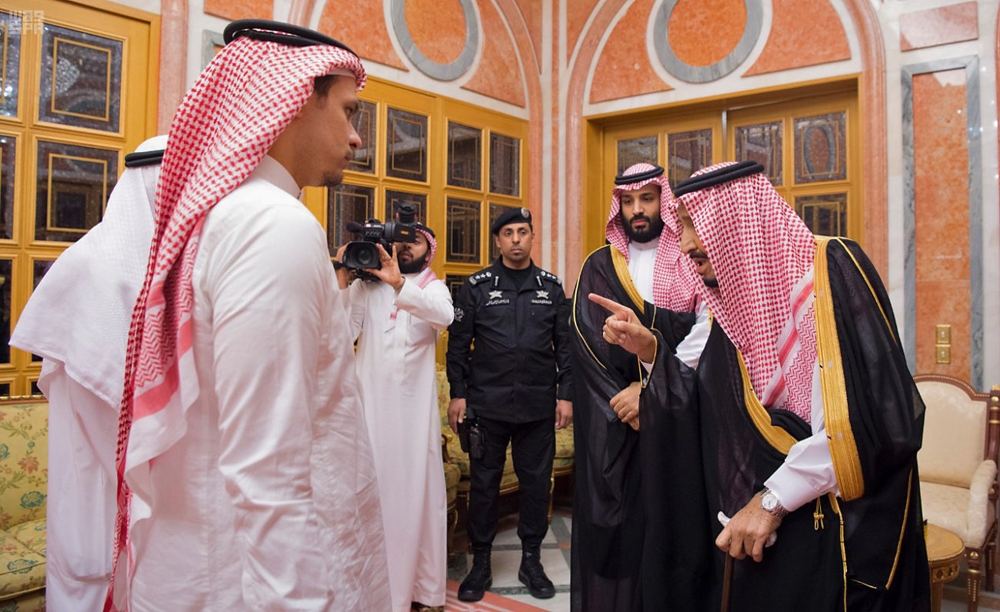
left=111, top=20, right=390, bottom=612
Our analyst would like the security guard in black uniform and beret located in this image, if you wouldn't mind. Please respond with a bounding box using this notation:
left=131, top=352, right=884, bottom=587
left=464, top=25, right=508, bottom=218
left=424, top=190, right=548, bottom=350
left=447, top=208, right=573, bottom=601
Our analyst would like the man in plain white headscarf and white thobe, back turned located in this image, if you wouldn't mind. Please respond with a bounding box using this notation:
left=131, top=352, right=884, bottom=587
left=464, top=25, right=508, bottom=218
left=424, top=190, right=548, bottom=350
left=10, top=136, right=167, bottom=610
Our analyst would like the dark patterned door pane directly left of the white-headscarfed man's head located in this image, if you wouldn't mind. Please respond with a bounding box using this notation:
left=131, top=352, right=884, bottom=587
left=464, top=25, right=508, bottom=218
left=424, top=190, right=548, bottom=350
left=35, top=140, right=119, bottom=242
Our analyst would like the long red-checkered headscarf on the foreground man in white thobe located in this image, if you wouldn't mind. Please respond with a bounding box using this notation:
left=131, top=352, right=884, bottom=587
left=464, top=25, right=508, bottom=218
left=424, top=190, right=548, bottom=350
left=105, top=38, right=366, bottom=610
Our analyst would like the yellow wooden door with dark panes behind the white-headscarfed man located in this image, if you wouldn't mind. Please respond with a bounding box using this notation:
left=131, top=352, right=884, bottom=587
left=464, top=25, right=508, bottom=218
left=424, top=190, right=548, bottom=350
left=0, top=0, right=159, bottom=395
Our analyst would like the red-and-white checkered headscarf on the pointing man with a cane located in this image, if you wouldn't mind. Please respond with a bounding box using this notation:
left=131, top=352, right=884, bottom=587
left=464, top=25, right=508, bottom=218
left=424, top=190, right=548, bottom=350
left=680, top=162, right=816, bottom=422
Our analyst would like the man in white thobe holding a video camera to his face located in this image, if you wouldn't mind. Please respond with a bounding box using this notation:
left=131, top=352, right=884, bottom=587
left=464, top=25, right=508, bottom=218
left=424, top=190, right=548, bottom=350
left=334, top=215, right=454, bottom=612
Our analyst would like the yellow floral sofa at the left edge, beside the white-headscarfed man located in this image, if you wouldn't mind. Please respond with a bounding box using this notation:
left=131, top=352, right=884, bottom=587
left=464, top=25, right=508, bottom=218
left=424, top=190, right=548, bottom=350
left=0, top=398, right=49, bottom=612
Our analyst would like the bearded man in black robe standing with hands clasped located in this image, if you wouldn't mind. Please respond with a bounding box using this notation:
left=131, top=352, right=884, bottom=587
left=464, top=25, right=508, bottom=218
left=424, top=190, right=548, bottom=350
left=571, top=163, right=708, bottom=612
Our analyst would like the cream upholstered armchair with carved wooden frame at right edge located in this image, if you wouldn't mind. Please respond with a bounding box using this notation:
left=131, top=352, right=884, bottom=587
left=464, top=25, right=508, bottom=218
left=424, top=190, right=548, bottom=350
left=914, top=374, right=1000, bottom=612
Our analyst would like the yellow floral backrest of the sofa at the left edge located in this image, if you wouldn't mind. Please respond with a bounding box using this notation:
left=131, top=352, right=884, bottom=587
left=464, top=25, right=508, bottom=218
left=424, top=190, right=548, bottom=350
left=0, top=403, right=49, bottom=529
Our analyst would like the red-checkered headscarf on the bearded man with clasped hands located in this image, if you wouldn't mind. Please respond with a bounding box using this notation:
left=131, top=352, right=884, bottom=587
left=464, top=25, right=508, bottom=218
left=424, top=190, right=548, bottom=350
left=605, top=163, right=701, bottom=312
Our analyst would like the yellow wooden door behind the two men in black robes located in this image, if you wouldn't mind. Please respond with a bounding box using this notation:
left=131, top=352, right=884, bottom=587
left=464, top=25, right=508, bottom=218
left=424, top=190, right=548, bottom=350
left=582, top=82, right=864, bottom=252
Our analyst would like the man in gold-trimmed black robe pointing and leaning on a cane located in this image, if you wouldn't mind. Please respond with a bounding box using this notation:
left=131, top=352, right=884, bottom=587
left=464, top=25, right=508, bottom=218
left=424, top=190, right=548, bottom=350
left=592, top=162, right=930, bottom=612
